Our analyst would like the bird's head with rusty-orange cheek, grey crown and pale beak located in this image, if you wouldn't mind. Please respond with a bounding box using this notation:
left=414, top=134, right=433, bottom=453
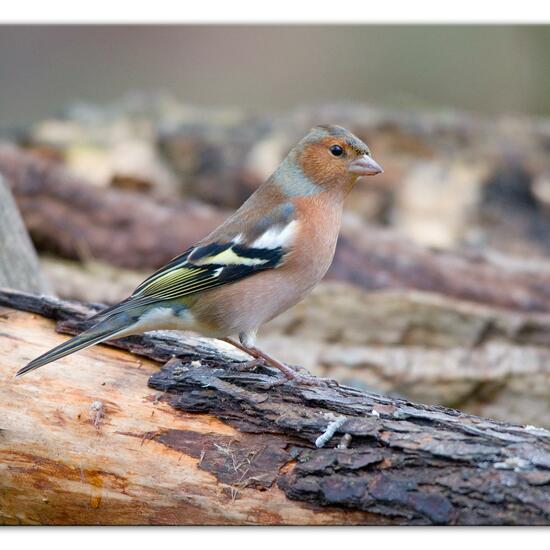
left=294, top=125, right=383, bottom=193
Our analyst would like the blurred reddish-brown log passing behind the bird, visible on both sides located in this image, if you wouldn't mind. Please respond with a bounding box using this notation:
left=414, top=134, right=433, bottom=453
left=4, top=144, right=550, bottom=311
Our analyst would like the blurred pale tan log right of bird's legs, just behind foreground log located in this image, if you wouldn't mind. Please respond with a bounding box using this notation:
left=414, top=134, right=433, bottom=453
left=259, top=282, right=550, bottom=428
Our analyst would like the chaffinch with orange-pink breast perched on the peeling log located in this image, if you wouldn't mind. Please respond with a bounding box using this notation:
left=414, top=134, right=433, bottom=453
left=16, top=125, right=383, bottom=383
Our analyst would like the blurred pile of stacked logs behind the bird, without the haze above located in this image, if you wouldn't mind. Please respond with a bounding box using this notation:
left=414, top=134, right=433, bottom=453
left=0, top=101, right=550, bottom=427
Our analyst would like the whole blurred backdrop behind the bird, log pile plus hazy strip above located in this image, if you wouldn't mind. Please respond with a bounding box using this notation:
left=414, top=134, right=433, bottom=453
left=0, top=25, right=550, bottom=427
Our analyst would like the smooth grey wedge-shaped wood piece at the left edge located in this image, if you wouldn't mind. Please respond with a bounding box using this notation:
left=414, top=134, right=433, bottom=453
left=0, top=174, right=48, bottom=294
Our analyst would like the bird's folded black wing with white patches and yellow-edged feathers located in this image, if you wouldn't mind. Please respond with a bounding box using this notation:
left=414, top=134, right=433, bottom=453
left=91, top=208, right=298, bottom=317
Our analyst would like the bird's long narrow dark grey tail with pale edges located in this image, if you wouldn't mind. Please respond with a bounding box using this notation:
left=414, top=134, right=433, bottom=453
left=15, top=313, right=133, bottom=376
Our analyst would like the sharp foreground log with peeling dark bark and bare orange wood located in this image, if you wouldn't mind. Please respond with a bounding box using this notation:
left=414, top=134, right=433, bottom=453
left=0, top=291, right=550, bottom=525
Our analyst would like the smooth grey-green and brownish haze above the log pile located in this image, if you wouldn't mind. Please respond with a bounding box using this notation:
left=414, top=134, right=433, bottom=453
left=0, top=25, right=550, bottom=126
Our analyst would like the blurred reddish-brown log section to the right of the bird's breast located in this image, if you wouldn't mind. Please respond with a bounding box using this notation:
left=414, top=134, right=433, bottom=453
left=334, top=221, right=550, bottom=312
